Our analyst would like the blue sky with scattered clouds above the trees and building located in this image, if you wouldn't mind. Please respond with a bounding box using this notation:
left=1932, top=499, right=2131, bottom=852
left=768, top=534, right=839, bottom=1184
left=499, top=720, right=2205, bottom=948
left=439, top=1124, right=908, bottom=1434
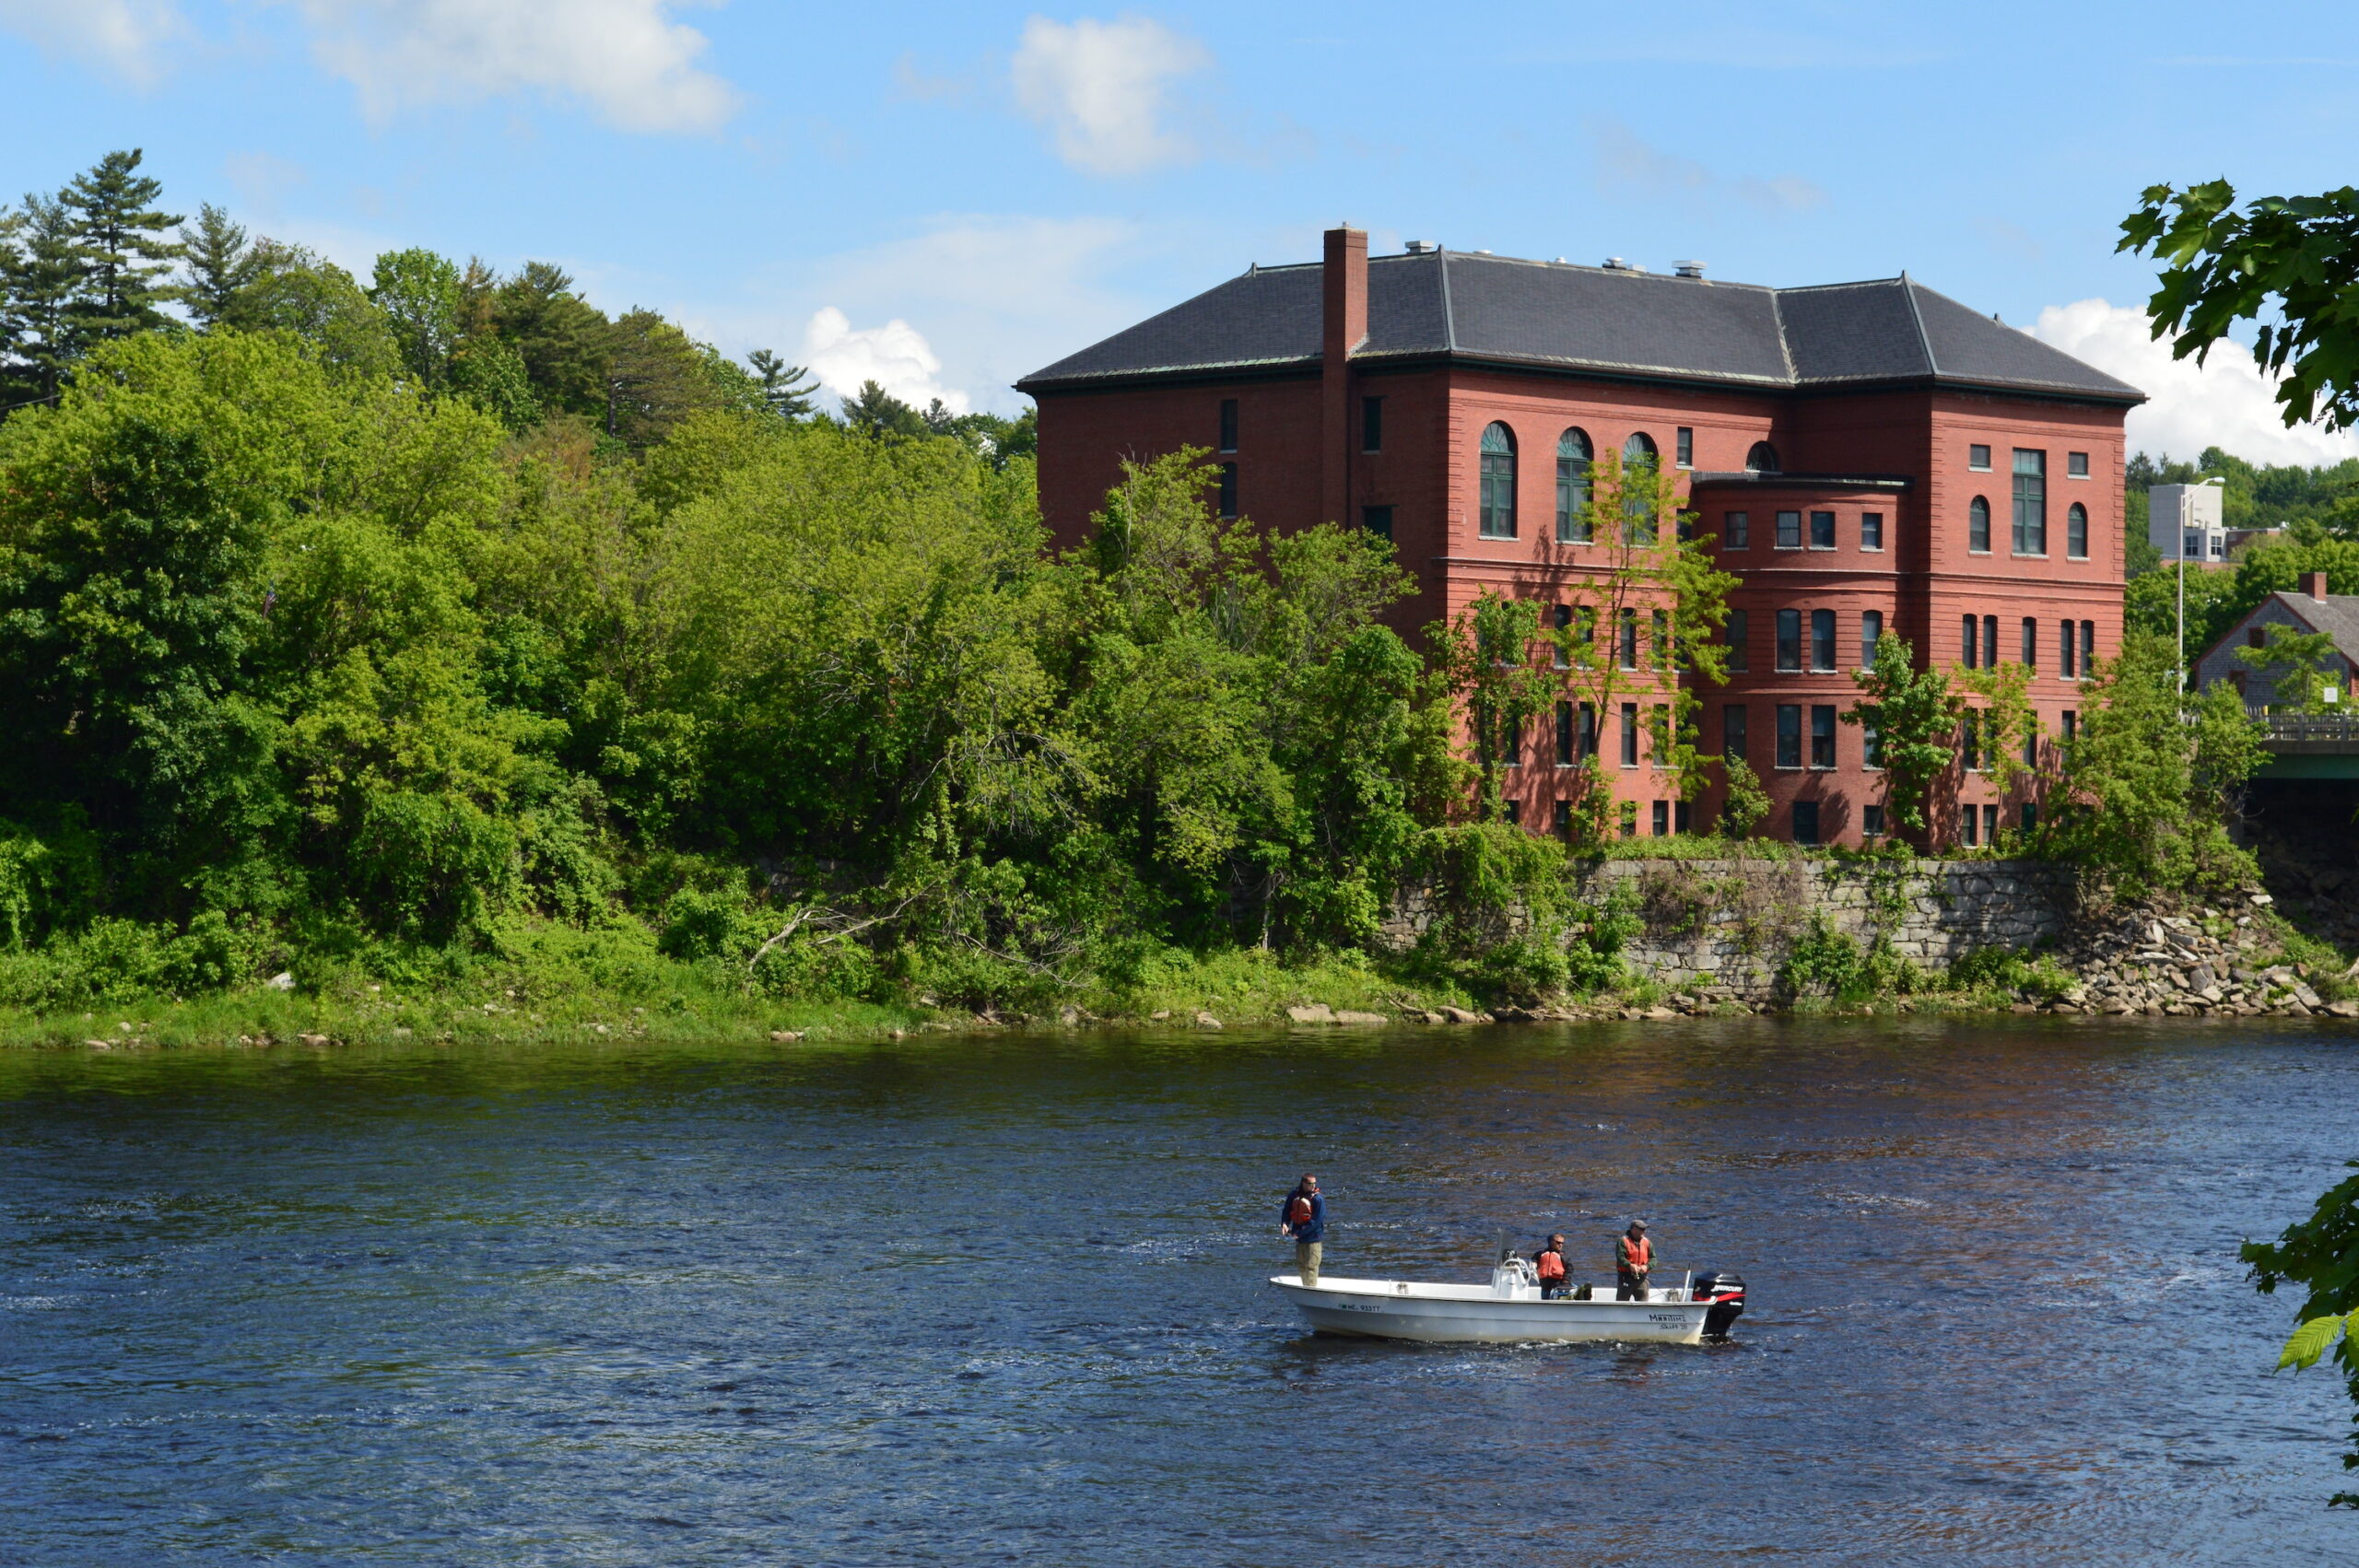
left=0, top=0, right=2359, bottom=460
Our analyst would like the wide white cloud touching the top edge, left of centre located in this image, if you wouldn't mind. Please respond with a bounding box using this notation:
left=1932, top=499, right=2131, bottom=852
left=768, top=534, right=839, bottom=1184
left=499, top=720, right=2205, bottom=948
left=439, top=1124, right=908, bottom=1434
left=292, top=0, right=738, bottom=132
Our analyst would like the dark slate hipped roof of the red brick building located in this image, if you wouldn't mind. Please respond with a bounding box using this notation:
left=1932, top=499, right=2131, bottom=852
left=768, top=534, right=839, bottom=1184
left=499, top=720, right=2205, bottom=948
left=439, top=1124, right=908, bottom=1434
left=1016, top=250, right=2144, bottom=404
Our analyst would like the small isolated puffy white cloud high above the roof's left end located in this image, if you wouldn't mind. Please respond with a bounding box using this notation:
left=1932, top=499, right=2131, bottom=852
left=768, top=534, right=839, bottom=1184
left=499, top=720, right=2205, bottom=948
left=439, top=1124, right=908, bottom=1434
left=1007, top=17, right=1213, bottom=174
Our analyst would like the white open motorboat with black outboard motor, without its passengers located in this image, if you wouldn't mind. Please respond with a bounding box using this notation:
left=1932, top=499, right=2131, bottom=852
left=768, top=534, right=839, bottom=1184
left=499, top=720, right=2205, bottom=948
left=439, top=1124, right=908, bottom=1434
left=1269, top=1257, right=1745, bottom=1344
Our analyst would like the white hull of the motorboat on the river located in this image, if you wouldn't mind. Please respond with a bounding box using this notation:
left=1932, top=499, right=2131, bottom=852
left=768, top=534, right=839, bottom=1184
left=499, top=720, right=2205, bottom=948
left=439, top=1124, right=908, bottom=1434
left=1269, top=1273, right=1713, bottom=1344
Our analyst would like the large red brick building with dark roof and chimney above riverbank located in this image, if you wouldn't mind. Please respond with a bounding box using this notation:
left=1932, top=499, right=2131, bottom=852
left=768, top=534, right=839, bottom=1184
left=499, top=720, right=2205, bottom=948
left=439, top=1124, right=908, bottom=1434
left=1019, top=228, right=2142, bottom=844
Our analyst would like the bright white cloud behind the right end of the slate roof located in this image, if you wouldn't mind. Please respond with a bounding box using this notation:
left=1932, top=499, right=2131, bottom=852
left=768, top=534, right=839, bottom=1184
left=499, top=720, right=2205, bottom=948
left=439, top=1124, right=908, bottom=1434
left=2031, top=299, right=2359, bottom=464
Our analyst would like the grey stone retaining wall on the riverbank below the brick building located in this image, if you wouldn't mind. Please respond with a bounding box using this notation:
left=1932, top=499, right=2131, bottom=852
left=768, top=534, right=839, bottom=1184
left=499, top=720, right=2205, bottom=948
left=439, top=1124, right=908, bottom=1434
left=1382, top=859, right=2076, bottom=1000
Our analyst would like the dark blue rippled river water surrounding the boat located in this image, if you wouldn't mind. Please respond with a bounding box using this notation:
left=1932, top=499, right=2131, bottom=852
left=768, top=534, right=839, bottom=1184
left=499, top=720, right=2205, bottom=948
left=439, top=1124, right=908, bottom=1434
left=0, top=1019, right=2359, bottom=1565
